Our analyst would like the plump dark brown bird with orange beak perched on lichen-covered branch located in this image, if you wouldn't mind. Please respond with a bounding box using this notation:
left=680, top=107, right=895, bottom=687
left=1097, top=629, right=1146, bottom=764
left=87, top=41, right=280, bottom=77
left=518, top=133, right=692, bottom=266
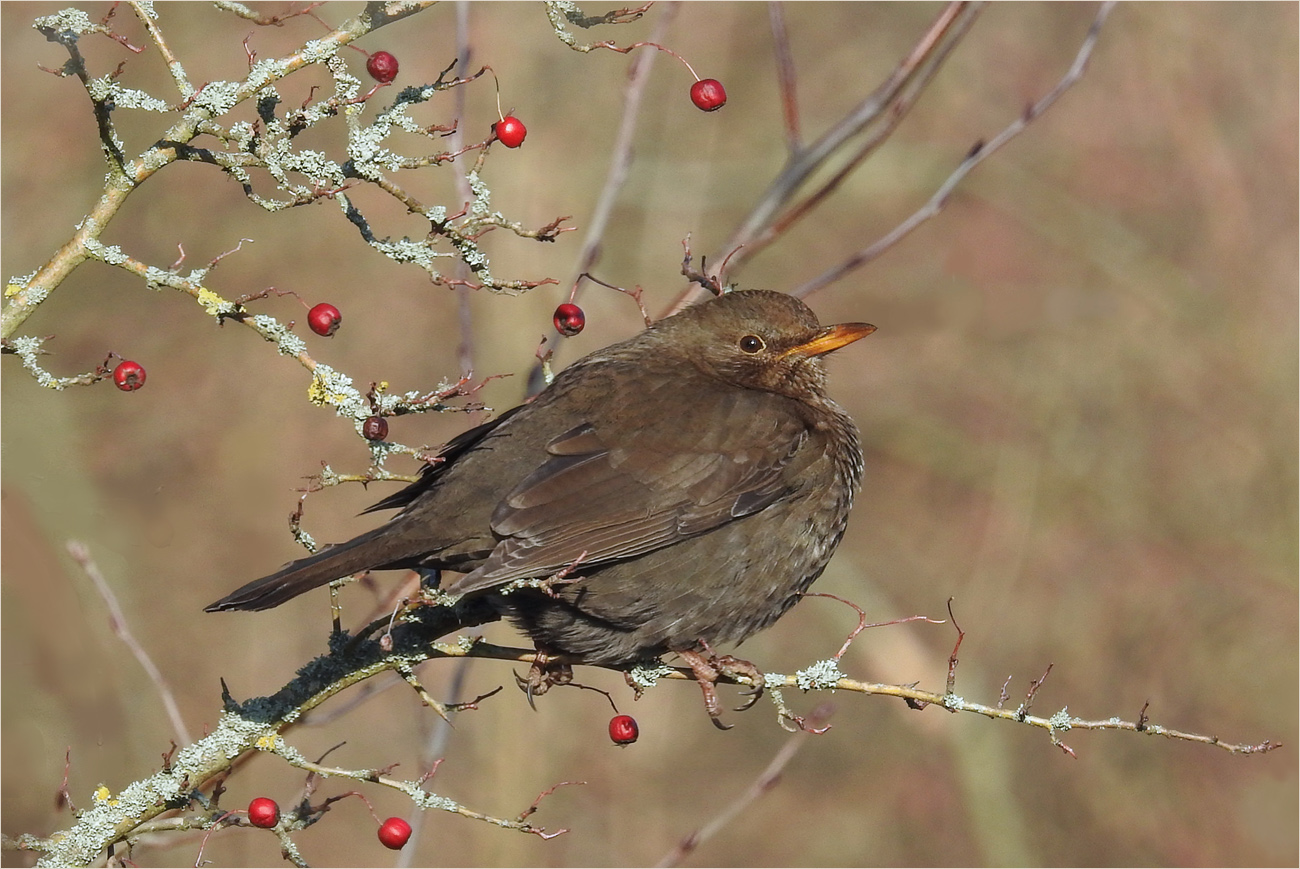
left=207, top=290, right=875, bottom=726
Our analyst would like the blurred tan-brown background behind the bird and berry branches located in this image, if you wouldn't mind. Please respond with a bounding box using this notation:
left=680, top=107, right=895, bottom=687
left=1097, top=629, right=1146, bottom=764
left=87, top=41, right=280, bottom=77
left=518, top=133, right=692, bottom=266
left=0, top=3, right=1300, bottom=866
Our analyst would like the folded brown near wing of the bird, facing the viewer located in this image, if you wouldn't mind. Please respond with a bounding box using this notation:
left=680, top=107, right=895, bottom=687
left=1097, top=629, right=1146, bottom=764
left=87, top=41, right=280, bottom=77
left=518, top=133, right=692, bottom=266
left=449, top=390, right=807, bottom=593
